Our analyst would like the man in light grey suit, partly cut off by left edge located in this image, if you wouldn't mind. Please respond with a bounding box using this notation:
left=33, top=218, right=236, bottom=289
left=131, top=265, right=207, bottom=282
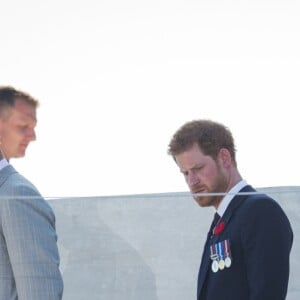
left=0, top=87, right=63, bottom=300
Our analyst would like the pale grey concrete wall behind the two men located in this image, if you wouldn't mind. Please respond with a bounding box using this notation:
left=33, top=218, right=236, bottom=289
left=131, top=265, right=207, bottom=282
left=48, top=187, right=300, bottom=300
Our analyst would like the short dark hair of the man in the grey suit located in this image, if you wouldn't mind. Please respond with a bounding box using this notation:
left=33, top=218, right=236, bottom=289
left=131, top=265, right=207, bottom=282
left=0, top=86, right=39, bottom=116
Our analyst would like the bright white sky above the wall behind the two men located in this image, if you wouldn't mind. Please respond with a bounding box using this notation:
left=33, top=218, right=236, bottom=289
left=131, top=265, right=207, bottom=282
left=0, top=0, right=300, bottom=197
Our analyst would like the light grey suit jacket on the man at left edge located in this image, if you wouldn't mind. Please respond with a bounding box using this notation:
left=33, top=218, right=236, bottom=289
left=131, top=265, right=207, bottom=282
left=0, top=165, right=63, bottom=300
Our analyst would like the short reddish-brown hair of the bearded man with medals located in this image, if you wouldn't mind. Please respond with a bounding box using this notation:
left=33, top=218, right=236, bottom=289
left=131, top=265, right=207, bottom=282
left=168, top=120, right=236, bottom=164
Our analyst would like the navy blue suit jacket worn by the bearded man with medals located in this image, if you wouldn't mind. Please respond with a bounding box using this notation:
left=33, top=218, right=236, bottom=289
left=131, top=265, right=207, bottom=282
left=197, top=186, right=293, bottom=300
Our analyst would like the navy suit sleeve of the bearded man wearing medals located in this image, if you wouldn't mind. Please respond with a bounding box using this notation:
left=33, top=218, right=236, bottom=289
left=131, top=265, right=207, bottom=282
left=241, top=199, right=293, bottom=300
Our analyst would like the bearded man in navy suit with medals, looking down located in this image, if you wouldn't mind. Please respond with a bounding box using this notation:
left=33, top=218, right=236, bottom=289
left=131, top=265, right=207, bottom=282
left=168, top=120, right=293, bottom=300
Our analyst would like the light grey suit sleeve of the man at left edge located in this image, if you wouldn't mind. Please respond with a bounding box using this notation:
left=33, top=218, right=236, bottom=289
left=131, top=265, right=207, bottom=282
left=1, top=185, right=63, bottom=300
